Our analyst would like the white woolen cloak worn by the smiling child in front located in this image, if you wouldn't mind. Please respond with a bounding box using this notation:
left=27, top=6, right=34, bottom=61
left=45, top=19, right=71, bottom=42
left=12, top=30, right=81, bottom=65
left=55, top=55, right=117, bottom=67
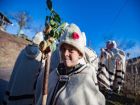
left=38, top=64, right=105, bottom=105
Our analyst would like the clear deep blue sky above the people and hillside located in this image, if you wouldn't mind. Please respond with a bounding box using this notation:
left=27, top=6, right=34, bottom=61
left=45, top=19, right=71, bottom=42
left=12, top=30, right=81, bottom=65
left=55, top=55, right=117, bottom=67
left=0, top=0, right=140, bottom=57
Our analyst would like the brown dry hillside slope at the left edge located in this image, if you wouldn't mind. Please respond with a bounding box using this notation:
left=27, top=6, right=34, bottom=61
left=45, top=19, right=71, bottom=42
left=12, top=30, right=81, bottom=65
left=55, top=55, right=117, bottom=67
left=0, top=31, right=29, bottom=79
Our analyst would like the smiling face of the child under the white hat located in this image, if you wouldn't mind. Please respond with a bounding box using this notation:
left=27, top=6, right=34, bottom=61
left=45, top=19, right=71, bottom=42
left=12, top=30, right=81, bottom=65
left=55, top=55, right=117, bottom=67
left=60, top=44, right=82, bottom=68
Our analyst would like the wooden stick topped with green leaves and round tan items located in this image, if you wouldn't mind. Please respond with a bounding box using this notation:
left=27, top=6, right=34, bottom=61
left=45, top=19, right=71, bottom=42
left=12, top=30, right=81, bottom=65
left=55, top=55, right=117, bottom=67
left=40, top=0, right=66, bottom=105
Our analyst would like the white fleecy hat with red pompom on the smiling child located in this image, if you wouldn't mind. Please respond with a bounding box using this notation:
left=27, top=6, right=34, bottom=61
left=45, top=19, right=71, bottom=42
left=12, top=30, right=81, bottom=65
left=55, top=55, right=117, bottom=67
left=60, top=24, right=86, bottom=55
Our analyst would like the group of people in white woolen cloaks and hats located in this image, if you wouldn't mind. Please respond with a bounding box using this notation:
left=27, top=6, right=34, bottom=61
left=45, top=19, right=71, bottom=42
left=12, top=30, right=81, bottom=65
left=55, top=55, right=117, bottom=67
left=3, top=24, right=125, bottom=105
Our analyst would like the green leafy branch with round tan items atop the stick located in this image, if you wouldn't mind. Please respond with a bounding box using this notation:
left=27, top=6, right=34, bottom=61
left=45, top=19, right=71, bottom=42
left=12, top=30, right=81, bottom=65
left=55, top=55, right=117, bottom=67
left=40, top=0, right=66, bottom=53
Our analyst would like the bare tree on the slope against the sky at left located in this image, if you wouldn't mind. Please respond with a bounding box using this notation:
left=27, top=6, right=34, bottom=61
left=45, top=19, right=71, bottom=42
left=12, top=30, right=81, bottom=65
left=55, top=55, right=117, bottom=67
left=13, top=11, right=32, bottom=36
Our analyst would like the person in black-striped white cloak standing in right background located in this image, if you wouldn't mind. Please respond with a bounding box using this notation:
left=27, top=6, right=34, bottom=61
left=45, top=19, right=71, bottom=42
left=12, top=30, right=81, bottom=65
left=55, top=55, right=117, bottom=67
left=98, top=40, right=126, bottom=92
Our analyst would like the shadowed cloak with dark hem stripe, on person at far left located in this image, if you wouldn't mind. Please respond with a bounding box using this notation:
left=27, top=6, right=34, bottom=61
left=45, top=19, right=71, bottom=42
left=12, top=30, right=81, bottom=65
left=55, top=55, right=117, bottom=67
left=4, top=44, right=43, bottom=105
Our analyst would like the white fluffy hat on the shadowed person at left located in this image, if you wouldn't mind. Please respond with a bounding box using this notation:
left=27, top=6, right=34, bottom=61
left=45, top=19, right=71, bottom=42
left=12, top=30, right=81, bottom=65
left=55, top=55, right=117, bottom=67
left=32, top=32, right=44, bottom=45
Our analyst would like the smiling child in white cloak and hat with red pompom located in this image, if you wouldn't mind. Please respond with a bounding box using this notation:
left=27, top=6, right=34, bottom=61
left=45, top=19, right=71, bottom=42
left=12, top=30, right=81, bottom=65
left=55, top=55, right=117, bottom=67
left=38, top=24, right=105, bottom=105
